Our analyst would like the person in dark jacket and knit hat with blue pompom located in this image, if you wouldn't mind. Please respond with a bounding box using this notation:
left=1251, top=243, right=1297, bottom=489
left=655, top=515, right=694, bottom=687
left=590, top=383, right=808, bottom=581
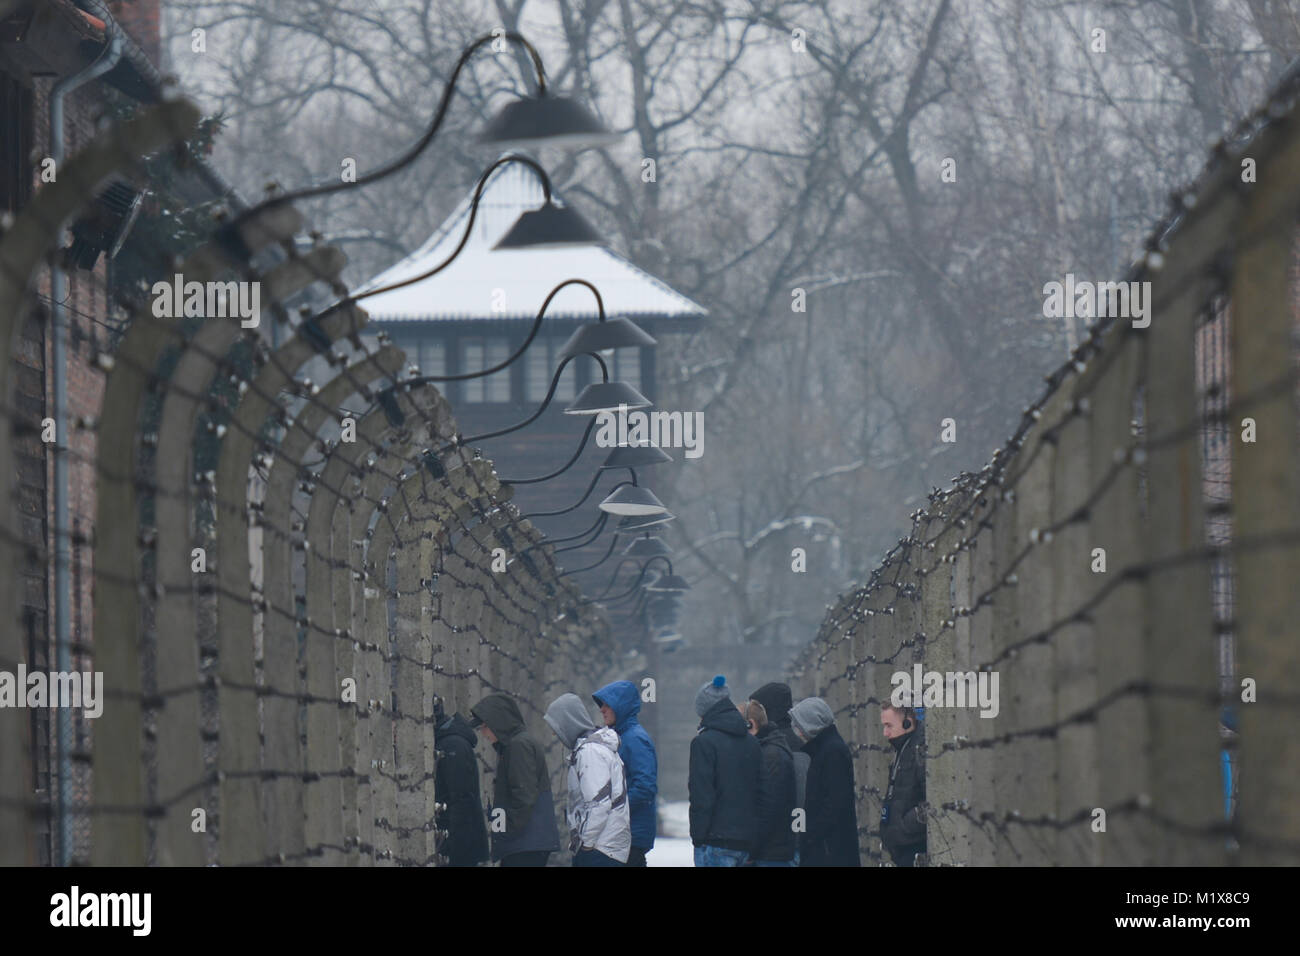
left=686, top=674, right=762, bottom=866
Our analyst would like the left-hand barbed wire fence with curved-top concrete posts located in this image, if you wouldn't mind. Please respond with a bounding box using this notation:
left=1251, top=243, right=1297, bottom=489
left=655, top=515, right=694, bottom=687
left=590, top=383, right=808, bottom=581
left=0, top=100, right=611, bottom=865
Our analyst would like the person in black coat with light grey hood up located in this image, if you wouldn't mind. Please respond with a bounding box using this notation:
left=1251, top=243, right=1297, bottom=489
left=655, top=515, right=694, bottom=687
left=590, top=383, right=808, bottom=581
left=790, top=697, right=862, bottom=866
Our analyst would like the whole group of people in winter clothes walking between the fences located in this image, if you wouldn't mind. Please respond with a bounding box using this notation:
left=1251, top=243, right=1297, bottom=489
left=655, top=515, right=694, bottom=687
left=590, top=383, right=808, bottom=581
left=434, top=675, right=926, bottom=866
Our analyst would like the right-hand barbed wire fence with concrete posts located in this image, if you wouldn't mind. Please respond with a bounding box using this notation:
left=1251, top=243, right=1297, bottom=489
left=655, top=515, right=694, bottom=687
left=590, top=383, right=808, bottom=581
left=792, top=75, right=1300, bottom=865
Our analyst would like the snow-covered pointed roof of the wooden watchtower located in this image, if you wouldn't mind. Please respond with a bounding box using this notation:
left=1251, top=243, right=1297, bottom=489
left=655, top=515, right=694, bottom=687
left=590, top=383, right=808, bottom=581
left=358, top=163, right=705, bottom=321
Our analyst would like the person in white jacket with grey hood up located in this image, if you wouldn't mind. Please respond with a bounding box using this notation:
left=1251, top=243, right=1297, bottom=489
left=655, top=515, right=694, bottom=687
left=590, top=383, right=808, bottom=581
left=545, top=693, right=632, bottom=866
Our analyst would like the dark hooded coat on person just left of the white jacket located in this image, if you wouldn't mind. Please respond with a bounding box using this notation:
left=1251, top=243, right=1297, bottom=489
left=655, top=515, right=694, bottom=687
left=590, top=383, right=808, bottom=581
left=469, top=693, right=560, bottom=860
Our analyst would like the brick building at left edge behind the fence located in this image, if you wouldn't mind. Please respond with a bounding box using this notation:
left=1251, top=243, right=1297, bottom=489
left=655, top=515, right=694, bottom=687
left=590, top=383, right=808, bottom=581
left=0, top=0, right=231, bottom=864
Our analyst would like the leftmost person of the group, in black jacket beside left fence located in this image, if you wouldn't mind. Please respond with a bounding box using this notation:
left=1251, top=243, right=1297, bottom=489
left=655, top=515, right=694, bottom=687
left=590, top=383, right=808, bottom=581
left=433, top=697, right=488, bottom=866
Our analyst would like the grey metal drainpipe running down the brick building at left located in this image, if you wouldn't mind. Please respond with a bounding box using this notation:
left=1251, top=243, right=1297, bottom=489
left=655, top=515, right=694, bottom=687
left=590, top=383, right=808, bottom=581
left=49, top=7, right=122, bottom=866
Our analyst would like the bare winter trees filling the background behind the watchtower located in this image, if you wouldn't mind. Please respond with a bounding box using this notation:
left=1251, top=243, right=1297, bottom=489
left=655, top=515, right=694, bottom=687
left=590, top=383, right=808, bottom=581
left=169, top=0, right=1300, bottom=655
